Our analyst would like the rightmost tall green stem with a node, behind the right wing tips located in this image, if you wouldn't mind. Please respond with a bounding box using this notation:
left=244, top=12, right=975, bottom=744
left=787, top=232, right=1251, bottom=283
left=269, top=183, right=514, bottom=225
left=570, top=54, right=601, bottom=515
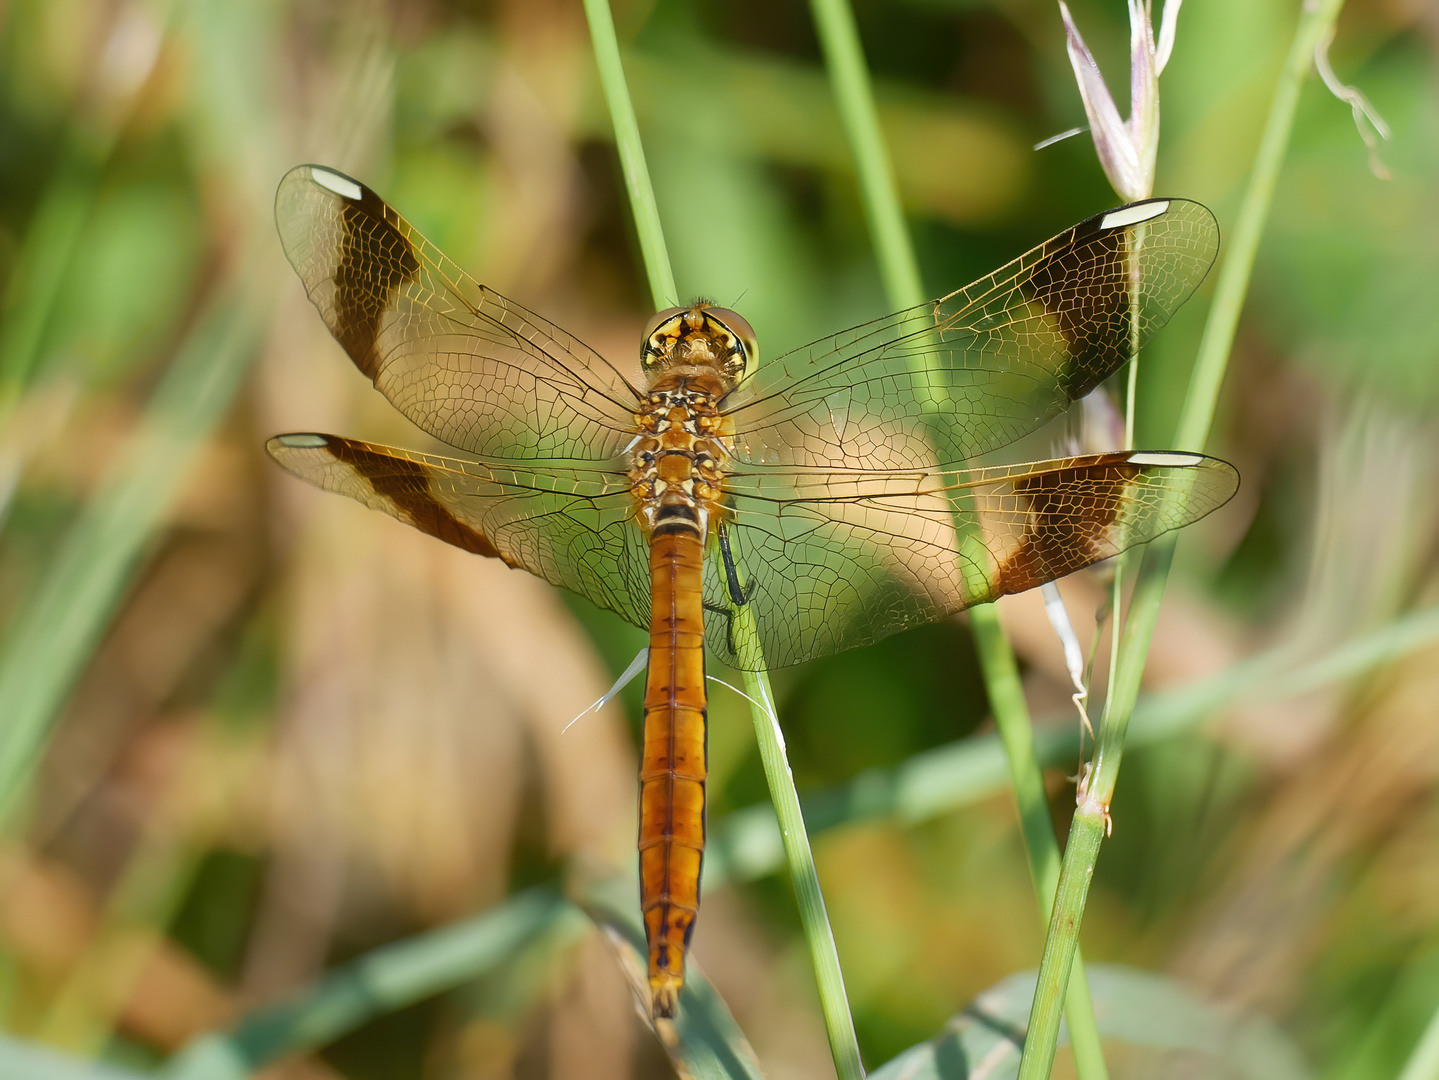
left=1019, top=0, right=1343, bottom=1080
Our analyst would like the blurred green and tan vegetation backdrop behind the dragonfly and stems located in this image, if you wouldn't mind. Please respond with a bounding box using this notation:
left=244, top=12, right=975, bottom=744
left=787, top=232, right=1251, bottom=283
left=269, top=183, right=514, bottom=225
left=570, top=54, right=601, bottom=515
left=0, top=0, right=1439, bottom=1080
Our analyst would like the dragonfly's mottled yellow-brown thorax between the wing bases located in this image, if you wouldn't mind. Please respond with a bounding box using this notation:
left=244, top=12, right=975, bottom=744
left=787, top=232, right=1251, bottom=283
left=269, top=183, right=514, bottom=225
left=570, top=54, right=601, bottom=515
left=629, top=371, right=730, bottom=541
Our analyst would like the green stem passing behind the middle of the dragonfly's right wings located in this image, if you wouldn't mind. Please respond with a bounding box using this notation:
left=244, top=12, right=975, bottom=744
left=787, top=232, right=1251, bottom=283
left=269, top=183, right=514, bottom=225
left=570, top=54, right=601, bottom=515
left=810, top=0, right=1108, bottom=1080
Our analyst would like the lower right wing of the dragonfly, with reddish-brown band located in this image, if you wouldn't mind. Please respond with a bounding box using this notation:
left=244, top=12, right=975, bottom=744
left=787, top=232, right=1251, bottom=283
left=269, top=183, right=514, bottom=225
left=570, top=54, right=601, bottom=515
left=705, top=453, right=1239, bottom=669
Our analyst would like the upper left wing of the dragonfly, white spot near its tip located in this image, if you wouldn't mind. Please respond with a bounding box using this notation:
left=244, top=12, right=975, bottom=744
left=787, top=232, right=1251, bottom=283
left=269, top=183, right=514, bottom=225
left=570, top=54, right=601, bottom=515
left=275, top=165, right=636, bottom=460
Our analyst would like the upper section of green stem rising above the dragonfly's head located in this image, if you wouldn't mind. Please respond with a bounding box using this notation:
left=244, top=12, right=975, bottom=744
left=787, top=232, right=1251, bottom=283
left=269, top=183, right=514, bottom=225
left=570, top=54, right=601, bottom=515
left=584, top=0, right=679, bottom=311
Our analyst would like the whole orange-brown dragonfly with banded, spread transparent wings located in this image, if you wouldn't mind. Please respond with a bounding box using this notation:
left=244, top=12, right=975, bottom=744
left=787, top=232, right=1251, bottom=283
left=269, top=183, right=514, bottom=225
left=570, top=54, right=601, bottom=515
left=266, top=165, right=1239, bottom=1018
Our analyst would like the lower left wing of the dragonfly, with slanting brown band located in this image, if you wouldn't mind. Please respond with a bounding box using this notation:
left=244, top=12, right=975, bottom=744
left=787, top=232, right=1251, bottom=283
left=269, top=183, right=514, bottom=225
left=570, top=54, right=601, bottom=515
left=265, top=434, right=649, bottom=627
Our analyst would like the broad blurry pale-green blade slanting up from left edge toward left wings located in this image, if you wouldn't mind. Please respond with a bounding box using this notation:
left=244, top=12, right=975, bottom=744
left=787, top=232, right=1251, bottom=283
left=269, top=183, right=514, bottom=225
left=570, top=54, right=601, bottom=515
left=0, top=276, right=262, bottom=814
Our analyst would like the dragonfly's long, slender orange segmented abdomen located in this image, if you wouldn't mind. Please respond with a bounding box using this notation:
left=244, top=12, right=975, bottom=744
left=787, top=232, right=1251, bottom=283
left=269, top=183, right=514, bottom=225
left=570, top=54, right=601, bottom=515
left=639, top=522, right=708, bottom=1017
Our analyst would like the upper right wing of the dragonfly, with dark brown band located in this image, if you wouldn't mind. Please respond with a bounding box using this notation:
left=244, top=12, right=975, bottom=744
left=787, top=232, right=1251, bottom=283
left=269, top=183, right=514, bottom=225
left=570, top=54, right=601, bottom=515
left=724, top=198, right=1219, bottom=469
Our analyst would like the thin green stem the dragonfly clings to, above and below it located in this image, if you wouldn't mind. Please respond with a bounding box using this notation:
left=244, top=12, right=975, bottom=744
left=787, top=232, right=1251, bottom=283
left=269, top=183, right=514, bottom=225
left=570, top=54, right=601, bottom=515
left=584, top=0, right=865, bottom=1080
